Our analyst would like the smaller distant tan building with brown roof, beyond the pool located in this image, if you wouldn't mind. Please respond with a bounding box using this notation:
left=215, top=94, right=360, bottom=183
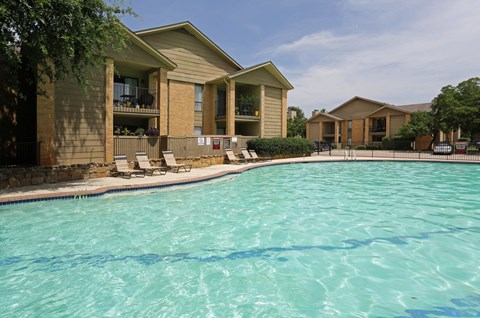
left=307, top=96, right=438, bottom=147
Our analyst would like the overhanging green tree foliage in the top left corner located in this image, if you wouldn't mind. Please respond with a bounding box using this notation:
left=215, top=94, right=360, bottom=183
left=0, top=0, right=134, bottom=97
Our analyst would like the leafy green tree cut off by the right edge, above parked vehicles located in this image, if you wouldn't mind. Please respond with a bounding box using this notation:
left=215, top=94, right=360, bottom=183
left=432, top=77, right=480, bottom=138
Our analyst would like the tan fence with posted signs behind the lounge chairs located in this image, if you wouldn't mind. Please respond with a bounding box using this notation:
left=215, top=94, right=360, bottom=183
left=113, top=135, right=257, bottom=160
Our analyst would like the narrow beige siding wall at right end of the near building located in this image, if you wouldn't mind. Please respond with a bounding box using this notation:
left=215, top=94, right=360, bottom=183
left=264, top=86, right=282, bottom=137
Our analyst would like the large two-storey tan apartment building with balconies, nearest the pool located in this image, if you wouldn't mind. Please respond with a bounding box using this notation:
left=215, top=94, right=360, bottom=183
left=32, top=22, right=293, bottom=165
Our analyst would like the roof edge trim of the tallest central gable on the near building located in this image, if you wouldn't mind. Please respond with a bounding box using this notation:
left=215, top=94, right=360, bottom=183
left=135, top=21, right=243, bottom=69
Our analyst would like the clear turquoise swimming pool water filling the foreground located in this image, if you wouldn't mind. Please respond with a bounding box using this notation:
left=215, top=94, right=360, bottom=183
left=0, top=162, right=480, bottom=317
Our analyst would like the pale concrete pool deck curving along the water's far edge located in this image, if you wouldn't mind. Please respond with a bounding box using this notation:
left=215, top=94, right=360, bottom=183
left=0, top=153, right=478, bottom=205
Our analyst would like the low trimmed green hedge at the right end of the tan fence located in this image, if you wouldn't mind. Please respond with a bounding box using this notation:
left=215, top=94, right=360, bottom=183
left=247, top=138, right=315, bottom=156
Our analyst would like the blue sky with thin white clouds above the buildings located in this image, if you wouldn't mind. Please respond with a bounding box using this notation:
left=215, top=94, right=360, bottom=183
left=123, top=0, right=480, bottom=117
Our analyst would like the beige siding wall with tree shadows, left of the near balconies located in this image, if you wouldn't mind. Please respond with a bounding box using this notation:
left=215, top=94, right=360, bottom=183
left=55, top=69, right=106, bottom=164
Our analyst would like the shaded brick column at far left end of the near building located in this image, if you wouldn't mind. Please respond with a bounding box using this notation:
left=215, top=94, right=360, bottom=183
left=37, top=75, right=56, bottom=166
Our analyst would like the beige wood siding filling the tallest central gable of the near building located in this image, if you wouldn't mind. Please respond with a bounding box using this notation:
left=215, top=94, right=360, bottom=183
left=142, top=31, right=238, bottom=84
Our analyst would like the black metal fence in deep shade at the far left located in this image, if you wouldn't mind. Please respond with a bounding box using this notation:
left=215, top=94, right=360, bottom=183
left=0, top=142, right=40, bottom=167
